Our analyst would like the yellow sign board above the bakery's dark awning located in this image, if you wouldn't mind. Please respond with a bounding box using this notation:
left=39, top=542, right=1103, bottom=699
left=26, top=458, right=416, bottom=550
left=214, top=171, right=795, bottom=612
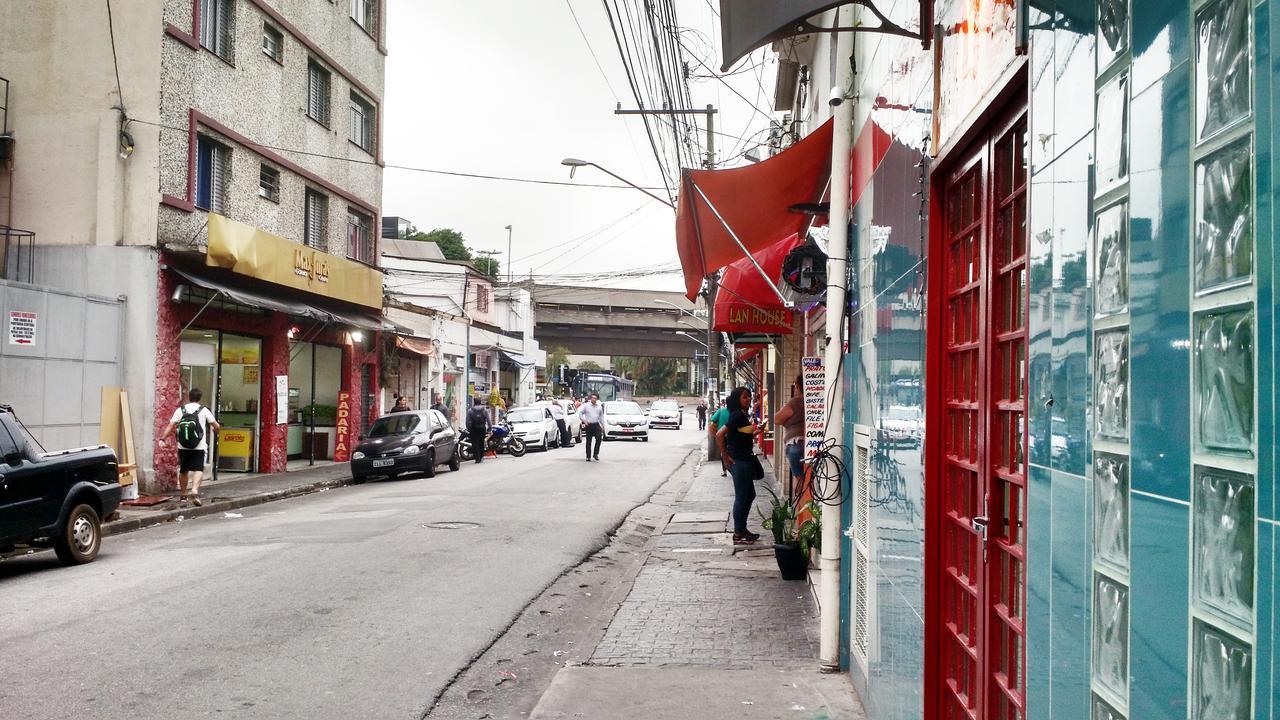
left=205, top=213, right=383, bottom=307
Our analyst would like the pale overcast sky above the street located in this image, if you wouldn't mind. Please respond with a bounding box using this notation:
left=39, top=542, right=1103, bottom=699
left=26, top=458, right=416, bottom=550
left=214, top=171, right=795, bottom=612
left=383, top=0, right=776, bottom=290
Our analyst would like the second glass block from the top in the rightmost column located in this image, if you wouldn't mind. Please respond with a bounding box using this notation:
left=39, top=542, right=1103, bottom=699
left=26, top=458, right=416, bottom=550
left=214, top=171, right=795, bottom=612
left=1196, top=138, right=1253, bottom=291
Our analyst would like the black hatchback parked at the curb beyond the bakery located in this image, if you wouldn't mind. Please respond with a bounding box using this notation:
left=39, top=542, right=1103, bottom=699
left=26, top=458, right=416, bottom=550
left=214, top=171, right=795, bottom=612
left=351, top=410, right=458, bottom=484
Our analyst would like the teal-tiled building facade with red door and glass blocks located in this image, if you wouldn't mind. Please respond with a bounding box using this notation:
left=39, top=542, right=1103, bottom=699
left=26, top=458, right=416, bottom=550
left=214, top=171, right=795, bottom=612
left=747, top=0, right=1280, bottom=720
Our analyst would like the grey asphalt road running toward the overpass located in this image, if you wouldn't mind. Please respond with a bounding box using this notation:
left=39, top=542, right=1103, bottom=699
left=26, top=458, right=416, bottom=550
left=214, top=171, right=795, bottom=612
left=0, top=414, right=703, bottom=720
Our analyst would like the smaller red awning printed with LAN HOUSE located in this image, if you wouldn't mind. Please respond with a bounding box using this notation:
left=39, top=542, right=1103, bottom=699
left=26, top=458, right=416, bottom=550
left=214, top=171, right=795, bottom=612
left=713, top=234, right=804, bottom=334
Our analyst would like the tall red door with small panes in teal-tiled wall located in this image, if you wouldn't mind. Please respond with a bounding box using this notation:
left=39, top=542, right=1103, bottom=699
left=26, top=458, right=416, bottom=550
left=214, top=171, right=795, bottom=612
left=928, top=111, right=1028, bottom=720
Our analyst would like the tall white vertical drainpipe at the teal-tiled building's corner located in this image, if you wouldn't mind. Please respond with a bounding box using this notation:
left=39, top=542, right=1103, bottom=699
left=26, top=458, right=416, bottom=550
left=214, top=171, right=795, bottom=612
left=818, top=5, right=854, bottom=673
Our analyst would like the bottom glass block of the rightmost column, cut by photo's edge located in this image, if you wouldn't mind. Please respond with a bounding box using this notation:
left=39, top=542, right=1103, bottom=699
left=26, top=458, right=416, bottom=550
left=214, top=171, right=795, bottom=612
left=1190, top=620, right=1253, bottom=720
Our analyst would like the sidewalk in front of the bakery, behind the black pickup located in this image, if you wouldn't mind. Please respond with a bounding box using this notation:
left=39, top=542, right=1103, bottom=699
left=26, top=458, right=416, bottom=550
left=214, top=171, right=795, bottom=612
left=102, top=462, right=351, bottom=536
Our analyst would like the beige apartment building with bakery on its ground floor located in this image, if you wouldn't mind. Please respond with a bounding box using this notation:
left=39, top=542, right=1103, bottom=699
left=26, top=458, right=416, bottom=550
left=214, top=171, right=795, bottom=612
left=0, top=0, right=385, bottom=489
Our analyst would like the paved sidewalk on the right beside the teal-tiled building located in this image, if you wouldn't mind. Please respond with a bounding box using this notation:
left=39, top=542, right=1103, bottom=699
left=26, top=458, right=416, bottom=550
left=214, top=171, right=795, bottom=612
left=531, top=453, right=865, bottom=720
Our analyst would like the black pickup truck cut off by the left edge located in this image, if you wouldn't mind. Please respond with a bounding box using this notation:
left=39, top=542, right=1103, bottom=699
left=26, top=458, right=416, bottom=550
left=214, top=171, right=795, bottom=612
left=0, top=405, right=120, bottom=565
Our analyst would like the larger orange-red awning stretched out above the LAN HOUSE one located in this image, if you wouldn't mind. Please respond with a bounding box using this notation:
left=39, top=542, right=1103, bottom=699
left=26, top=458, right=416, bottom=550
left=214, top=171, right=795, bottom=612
left=676, top=120, right=832, bottom=300
